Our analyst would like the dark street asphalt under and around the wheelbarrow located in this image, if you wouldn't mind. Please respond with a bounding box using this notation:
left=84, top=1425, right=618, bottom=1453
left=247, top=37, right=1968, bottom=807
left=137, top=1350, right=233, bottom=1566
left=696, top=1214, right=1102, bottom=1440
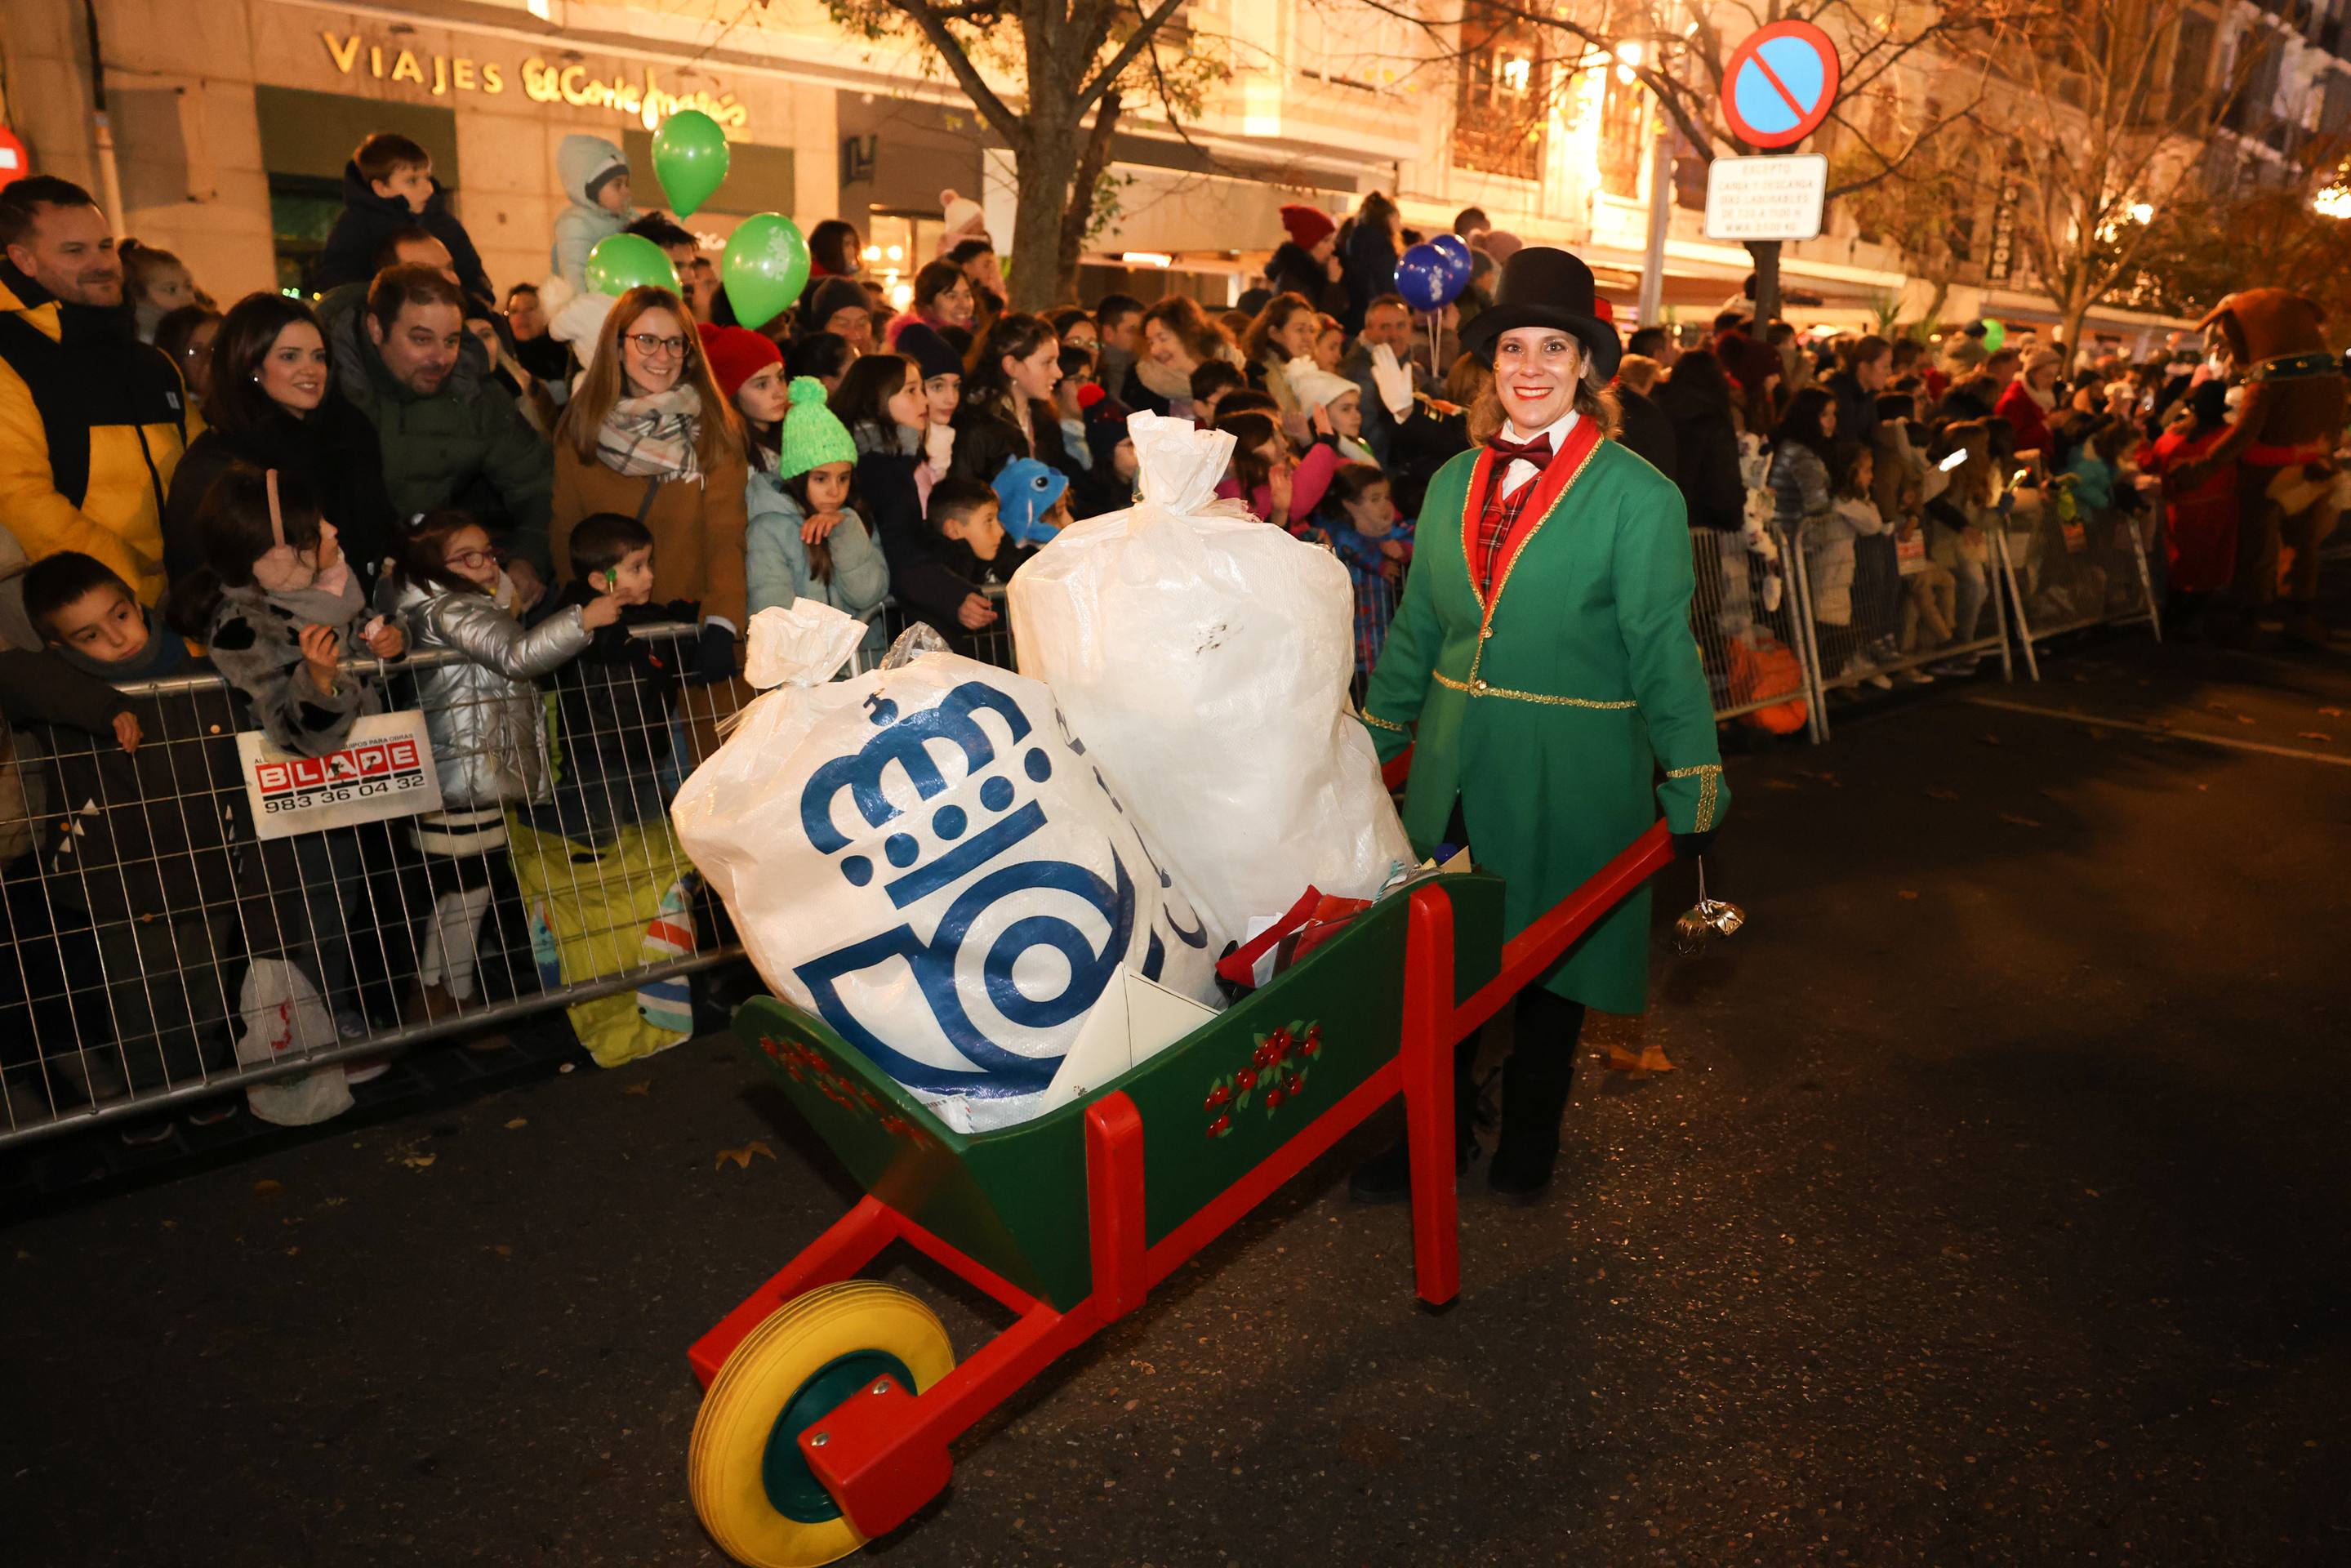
left=0, top=581, right=2351, bottom=1568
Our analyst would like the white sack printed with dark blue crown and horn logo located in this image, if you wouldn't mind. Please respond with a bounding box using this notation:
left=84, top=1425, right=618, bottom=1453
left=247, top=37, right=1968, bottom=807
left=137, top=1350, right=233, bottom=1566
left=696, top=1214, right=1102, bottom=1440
left=672, top=599, right=1215, bottom=1131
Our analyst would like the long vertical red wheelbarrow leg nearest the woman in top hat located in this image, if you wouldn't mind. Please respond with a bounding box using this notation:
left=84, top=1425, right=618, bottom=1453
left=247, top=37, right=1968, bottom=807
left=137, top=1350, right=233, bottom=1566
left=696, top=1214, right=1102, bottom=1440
left=1396, top=889, right=1463, bottom=1307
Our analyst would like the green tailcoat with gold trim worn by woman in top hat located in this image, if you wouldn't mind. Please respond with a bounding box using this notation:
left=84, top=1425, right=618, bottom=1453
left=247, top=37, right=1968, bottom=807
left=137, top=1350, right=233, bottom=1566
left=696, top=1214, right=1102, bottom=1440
left=1364, top=439, right=1730, bottom=1013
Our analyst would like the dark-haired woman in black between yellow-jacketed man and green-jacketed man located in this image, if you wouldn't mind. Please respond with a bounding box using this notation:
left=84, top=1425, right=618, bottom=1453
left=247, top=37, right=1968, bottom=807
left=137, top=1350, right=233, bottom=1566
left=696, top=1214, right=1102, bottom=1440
left=158, top=294, right=398, bottom=586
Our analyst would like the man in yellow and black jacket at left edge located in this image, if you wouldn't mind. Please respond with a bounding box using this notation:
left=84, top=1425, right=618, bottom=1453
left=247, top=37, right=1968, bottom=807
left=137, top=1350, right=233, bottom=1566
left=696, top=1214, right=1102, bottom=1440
left=0, top=174, right=188, bottom=604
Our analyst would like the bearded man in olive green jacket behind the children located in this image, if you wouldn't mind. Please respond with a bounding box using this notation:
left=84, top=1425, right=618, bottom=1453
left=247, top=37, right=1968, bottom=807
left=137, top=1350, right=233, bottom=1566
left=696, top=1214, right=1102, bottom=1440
left=318, top=265, right=554, bottom=609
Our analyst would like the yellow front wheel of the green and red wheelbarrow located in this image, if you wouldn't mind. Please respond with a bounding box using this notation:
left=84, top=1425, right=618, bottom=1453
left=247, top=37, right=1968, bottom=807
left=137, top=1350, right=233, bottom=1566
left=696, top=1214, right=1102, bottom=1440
left=687, top=1279, right=955, bottom=1568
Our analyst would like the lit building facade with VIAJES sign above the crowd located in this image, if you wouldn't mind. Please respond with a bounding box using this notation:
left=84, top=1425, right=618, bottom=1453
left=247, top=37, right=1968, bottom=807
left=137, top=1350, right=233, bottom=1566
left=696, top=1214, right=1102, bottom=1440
left=0, top=0, right=2351, bottom=327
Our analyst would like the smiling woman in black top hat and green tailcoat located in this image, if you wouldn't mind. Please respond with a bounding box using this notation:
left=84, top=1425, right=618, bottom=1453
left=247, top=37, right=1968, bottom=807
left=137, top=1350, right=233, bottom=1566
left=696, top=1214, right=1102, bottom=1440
left=1350, top=247, right=1730, bottom=1201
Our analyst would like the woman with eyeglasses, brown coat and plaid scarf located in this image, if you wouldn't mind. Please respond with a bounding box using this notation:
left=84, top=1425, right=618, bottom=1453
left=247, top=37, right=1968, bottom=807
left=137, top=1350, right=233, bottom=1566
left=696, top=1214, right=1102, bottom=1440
left=548, top=289, right=750, bottom=684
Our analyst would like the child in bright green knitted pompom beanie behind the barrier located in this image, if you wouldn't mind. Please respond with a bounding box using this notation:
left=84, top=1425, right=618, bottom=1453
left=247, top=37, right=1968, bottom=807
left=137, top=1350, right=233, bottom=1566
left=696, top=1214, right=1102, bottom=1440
left=743, top=376, right=888, bottom=630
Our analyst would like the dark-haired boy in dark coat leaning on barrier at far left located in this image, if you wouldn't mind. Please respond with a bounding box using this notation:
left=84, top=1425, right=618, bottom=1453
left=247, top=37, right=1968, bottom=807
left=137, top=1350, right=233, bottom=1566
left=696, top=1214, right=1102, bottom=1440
left=5, top=550, right=249, bottom=1114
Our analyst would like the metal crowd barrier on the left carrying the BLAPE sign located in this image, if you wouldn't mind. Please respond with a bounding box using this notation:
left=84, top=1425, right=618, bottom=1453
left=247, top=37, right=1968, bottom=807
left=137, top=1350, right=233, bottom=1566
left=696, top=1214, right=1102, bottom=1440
left=0, top=626, right=750, bottom=1145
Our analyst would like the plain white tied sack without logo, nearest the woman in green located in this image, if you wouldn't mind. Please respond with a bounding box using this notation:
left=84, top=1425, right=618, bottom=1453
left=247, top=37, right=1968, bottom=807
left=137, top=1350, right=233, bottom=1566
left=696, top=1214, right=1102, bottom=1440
left=1011, top=414, right=1413, bottom=950
